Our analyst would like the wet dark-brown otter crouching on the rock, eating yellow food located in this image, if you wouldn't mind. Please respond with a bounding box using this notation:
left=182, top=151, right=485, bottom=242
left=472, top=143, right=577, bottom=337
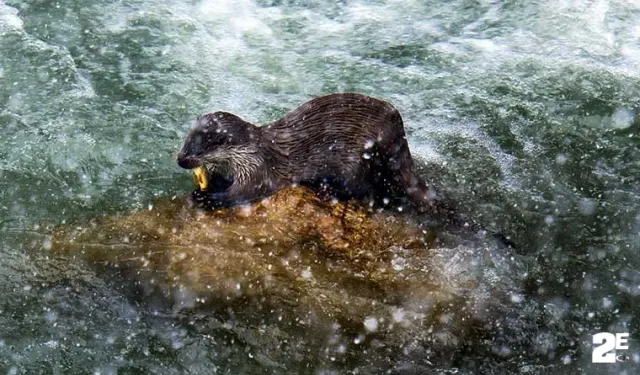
left=177, top=93, right=512, bottom=245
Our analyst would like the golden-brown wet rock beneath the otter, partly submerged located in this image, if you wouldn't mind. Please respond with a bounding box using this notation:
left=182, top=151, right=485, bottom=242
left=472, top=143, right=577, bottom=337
left=40, top=187, right=524, bottom=368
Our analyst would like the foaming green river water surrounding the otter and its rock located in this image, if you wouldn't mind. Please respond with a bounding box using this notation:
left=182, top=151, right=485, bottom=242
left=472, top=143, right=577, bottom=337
left=0, top=0, right=640, bottom=374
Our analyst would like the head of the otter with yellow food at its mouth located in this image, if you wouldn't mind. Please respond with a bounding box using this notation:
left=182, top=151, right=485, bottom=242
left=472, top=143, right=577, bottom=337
left=178, top=112, right=258, bottom=191
